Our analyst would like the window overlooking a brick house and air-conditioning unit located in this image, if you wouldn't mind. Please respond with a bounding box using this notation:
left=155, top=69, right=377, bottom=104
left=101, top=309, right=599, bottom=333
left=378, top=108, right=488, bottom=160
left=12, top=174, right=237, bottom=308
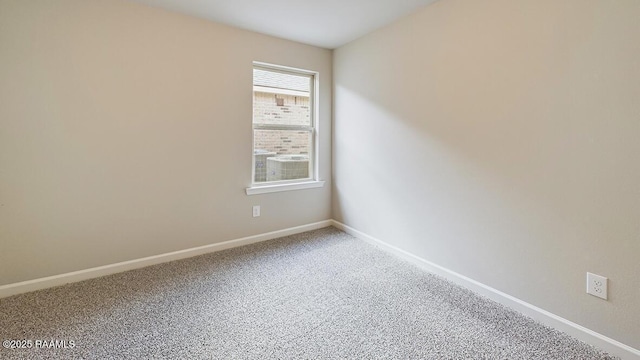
left=252, top=64, right=316, bottom=188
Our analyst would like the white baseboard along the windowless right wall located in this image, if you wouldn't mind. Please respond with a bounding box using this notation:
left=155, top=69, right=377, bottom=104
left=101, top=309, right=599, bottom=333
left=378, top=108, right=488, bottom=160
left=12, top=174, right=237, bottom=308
left=332, top=220, right=640, bottom=360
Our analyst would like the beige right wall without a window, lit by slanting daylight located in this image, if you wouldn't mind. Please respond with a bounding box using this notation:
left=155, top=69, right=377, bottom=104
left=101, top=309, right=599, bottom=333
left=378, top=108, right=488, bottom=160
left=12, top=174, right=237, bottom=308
left=333, top=0, right=640, bottom=348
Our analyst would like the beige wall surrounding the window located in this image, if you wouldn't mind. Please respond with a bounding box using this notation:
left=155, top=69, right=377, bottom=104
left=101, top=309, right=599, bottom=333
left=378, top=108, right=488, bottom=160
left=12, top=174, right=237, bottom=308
left=0, top=0, right=332, bottom=285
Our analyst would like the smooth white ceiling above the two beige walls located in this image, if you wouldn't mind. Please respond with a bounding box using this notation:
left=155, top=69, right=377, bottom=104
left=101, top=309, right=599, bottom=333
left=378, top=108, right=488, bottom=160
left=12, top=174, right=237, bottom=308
left=132, top=0, right=436, bottom=49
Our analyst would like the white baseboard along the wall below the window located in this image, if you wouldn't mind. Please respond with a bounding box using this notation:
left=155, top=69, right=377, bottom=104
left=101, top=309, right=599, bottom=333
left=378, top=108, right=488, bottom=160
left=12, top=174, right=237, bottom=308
left=0, top=220, right=333, bottom=299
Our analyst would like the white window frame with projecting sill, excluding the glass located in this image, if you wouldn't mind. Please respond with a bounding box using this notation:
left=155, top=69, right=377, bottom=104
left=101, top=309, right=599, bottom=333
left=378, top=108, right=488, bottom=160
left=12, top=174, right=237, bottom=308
left=246, top=62, right=324, bottom=195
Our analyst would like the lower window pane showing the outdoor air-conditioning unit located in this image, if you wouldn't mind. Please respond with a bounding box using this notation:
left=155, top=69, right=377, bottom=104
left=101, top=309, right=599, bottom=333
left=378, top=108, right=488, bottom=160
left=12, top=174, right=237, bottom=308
left=253, top=130, right=311, bottom=182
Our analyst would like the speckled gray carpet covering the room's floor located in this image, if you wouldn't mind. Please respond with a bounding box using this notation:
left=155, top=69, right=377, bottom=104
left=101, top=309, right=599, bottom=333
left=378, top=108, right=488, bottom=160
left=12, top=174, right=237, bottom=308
left=0, top=228, right=612, bottom=360
